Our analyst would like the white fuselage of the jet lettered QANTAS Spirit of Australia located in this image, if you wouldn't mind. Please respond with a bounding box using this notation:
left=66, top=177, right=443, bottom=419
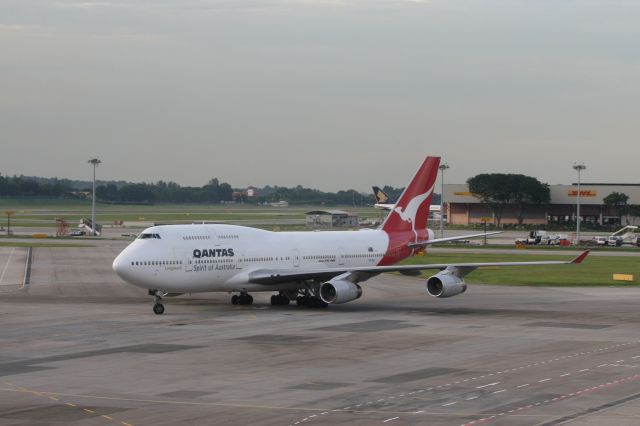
left=113, top=225, right=389, bottom=293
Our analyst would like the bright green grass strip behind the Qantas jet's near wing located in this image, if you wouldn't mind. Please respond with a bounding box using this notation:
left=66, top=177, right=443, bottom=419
left=403, top=253, right=640, bottom=287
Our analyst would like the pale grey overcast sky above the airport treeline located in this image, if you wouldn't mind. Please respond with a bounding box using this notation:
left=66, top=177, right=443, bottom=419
left=0, top=0, right=640, bottom=191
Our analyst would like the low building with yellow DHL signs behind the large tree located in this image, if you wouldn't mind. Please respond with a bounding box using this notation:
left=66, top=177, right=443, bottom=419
left=444, top=183, right=640, bottom=225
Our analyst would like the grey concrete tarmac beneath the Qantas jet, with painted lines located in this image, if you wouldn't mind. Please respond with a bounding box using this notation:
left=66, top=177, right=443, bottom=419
left=0, top=245, right=640, bottom=426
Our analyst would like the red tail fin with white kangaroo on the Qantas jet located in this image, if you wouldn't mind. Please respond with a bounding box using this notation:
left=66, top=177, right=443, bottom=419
left=382, top=157, right=440, bottom=237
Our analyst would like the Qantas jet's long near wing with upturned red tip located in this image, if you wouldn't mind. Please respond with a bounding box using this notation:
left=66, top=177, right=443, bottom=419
left=249, top=250, right=590, bottom=284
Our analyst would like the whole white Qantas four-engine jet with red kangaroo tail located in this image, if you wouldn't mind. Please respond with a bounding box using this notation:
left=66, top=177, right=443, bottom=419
left=113, top=157, right=589, bottom=315
